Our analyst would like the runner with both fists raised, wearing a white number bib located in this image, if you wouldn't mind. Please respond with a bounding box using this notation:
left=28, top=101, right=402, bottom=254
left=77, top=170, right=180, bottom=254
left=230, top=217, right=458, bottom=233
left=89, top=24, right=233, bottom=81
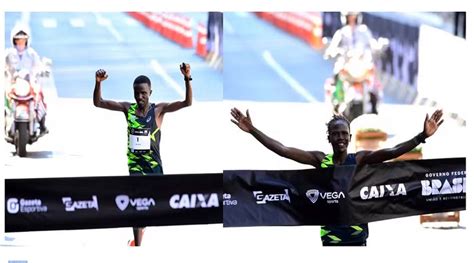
left=94, top=63, right=193, bottom=246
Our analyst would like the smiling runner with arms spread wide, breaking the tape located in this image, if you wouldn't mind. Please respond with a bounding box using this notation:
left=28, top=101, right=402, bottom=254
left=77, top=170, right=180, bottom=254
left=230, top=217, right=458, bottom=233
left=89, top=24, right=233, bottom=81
left=231, top=108, right=444, bottom=246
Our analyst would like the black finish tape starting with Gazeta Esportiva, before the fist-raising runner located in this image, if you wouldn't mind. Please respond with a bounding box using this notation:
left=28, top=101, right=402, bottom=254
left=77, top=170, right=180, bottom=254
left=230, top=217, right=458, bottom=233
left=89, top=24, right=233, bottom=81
left=5, top=174, right=223, bottom=232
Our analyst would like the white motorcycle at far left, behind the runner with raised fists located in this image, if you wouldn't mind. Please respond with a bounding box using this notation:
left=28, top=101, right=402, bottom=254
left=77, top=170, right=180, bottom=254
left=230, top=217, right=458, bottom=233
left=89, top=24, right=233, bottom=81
left=5, top=59, right=51, bottom=157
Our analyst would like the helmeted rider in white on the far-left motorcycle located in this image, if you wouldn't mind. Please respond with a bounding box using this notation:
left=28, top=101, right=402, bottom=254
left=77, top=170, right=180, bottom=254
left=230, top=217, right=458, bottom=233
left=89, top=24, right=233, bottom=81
left=5, top=25, right=49, bottom=135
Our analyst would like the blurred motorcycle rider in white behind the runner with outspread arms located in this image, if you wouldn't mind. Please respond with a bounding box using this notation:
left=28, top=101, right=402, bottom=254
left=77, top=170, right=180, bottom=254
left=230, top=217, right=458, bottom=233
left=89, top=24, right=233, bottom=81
left=325, top=12, right=379, bottom=114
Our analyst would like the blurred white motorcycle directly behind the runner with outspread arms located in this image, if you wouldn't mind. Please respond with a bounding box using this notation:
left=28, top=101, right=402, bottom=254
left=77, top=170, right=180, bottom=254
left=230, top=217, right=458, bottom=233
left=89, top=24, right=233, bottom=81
left=325, top=38, right=388, bottom=121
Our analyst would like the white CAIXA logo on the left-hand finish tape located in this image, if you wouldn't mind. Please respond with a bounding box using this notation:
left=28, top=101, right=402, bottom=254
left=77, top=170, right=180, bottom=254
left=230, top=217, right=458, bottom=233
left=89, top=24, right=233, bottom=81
left=170, top=193, right=219, bottom=209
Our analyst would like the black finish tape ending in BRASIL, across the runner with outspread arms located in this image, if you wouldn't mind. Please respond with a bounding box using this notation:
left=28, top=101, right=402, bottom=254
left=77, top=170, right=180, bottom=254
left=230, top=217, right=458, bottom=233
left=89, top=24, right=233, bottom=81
left=223, top=158, right=466, bottom=227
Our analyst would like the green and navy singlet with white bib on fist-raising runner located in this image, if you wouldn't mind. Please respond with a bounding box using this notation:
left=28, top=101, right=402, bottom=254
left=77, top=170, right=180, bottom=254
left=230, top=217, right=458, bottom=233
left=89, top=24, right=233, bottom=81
left=126, top=103, right=163, bottom=175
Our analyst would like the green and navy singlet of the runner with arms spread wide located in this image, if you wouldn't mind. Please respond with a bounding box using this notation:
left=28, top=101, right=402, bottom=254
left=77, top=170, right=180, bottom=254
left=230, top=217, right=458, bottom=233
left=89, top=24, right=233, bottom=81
left=321, top=153, right=369, bottom=246
